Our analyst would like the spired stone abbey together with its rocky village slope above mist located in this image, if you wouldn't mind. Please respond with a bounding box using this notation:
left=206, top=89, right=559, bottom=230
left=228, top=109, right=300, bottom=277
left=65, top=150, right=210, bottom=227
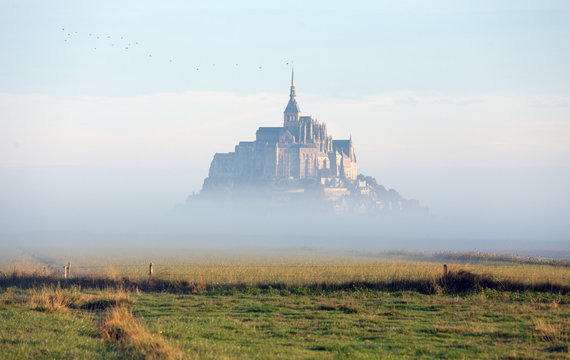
left=195, top=73, right=421, bottom=214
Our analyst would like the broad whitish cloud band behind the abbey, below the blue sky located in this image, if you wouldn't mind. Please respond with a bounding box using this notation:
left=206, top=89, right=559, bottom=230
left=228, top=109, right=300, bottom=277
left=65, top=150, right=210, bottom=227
left=0, top=91, right=570, bottom=168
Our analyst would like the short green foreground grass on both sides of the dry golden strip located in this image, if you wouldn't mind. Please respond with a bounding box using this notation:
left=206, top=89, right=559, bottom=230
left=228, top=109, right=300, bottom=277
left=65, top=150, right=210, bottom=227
left=0, top=288, right=570, bottom=359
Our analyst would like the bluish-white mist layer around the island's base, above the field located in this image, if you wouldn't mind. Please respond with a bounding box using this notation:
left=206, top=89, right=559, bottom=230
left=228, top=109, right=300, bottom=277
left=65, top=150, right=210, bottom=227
left=0, top=167, right=570, bottom=257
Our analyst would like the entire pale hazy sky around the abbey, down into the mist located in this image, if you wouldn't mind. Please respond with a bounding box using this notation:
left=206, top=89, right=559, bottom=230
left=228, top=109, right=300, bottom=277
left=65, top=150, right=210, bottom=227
left=0, top=0, right=570, bottom=248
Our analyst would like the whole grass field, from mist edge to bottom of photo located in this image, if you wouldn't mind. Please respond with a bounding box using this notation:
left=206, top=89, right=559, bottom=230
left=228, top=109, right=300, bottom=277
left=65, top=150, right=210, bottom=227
left=0, top=254, right=570, bottom=359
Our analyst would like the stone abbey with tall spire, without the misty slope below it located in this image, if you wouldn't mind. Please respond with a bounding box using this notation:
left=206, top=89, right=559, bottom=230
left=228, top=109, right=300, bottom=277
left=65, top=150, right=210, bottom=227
left=205, top=72, right=357, bottom=185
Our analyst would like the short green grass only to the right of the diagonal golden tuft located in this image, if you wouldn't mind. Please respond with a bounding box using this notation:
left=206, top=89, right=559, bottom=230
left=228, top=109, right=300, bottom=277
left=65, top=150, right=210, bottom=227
left=135, top=291, right=570, bottom=359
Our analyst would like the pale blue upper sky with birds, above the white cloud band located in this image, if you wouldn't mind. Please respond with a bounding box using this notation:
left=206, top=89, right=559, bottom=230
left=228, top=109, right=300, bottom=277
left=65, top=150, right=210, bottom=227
left=0, top=0, right=570, bottom=97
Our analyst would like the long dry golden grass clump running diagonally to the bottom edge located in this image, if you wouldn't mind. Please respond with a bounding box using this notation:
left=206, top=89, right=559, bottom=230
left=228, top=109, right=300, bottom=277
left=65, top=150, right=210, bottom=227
left=99, top=306, right=182, bottom=359
